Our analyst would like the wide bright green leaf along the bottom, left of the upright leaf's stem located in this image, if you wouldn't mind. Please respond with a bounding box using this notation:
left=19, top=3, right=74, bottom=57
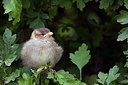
left=48, top=70, right=86, bottom=85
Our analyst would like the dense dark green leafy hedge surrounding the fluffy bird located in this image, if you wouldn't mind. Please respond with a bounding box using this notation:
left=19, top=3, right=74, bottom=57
left=0, top=0, right=128, bottom=85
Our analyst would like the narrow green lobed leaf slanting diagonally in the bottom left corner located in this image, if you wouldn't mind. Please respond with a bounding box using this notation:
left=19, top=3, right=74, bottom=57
left=5, top=69, right=20, bottom=84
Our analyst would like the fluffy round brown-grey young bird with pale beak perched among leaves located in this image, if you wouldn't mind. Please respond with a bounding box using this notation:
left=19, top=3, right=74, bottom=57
left=20, top=28, right=63, bottom=68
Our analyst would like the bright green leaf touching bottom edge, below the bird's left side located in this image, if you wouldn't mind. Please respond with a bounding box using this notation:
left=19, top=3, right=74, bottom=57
left=18, top=73, right=36, bottom=85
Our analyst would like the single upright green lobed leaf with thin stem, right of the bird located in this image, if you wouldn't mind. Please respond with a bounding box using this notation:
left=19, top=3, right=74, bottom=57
left=70, top=43, right=91, bottom=79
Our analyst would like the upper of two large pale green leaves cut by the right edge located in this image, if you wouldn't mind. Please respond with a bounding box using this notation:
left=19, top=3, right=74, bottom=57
left=116, top=10, right=128, bottom=24
